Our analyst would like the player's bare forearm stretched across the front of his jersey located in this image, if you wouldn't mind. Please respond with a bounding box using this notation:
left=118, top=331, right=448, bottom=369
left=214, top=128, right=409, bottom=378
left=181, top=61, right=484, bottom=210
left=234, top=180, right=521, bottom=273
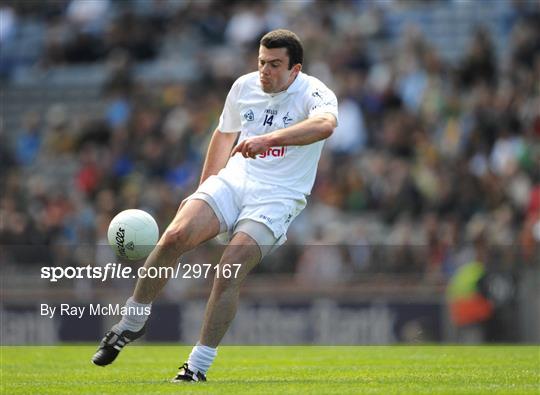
left=232, top=113, right=337, bottom=159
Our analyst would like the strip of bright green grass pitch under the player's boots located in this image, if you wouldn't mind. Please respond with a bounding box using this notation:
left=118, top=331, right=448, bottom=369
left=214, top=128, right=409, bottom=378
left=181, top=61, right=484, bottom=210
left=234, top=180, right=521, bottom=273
left=1, top=345, right=540, bottom=395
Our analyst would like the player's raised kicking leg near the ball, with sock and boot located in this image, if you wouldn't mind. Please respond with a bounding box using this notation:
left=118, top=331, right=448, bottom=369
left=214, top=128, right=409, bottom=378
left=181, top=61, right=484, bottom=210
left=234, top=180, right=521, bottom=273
left=92, top=199, right=220, bottom=366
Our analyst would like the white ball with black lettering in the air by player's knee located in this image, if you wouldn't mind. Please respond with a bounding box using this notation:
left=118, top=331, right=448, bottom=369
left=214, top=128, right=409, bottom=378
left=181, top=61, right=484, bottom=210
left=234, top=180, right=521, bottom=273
left=107, top=209, right=159, bottom=261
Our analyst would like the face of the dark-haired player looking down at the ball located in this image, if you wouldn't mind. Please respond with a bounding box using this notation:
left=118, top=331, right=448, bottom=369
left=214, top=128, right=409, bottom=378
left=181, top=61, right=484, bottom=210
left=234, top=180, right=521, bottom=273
left=259, top=45, right=302, bottom=93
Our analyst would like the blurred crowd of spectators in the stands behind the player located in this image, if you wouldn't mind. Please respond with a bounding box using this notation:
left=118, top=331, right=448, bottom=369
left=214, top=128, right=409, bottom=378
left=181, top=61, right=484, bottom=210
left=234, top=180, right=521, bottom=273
left=0, top=0, right=540, bottom=282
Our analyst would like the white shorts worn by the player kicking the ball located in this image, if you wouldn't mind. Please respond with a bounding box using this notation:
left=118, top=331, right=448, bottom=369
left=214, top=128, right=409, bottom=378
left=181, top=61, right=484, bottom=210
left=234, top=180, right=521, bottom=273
left=188, top=169, right=306, bottom=256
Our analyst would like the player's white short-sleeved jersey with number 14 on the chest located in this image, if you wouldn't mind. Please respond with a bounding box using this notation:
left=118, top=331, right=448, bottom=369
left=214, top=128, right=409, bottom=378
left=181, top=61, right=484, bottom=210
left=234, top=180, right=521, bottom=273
left=218, top=72, right=338, bottom=195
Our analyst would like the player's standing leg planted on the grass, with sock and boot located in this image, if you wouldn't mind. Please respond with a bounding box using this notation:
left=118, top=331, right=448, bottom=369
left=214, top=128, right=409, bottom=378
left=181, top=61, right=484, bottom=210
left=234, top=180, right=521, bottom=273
left=173, top=232, right=261, bottom=381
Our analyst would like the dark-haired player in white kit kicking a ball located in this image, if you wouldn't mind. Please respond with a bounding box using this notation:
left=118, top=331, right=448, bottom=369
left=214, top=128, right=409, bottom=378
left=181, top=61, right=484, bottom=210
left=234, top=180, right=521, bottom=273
left=92, top=29, right=338, bottom=382
